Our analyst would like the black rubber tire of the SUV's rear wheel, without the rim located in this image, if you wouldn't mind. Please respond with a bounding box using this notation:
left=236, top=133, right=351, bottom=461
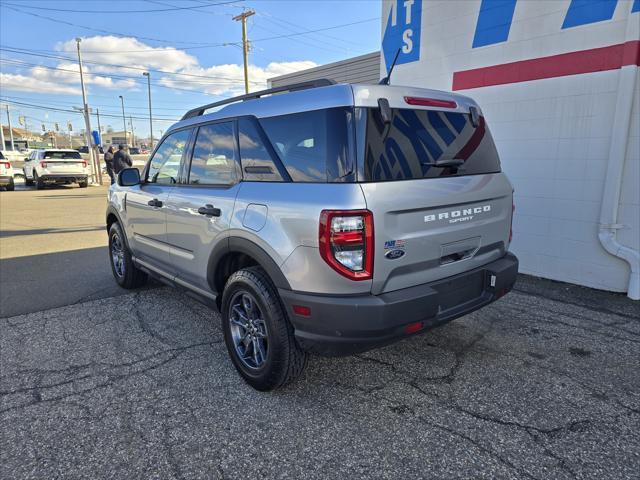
left=222, top=267, right=307, bottom=391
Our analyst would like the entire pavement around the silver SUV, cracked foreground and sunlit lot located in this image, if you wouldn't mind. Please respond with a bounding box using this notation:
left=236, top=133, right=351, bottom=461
left=0, top=182, right=640, bottom=479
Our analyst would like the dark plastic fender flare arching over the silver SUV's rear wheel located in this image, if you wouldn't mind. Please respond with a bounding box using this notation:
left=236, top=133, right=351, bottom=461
left=207, top=237, right=291, bottom=293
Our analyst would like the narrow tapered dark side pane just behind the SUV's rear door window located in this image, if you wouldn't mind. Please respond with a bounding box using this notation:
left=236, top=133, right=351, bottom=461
left=238, top=118, right=283, bottom=182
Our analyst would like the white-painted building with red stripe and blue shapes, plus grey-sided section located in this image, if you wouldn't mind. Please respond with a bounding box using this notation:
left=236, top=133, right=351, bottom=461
left=272, top=0, right=640, bottom=299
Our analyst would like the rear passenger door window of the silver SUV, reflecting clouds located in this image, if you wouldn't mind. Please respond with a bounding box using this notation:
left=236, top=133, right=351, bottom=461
left=189, top=122, right=236, bottom=185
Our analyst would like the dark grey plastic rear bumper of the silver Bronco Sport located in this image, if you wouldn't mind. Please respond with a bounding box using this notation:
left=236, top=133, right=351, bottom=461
left=279, top=253, right=518, bottom=356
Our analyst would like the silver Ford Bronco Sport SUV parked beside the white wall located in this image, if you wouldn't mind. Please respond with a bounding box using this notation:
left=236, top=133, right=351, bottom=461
left=106, top=81, right=518, bottom=390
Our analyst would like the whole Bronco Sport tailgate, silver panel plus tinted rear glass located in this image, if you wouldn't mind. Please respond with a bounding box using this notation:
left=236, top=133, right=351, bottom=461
left=358, top=102, right=512, bottom=294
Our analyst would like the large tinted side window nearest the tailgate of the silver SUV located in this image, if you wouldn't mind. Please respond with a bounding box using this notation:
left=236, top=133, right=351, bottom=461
left=260, top=108, right=353, bottom=182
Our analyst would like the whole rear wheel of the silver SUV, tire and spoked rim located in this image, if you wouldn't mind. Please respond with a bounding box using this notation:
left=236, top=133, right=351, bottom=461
left=222, top=267, right=307, bottom=391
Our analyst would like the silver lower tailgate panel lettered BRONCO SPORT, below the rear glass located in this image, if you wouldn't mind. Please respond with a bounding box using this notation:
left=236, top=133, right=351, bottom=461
left=361, top=173, right=512, bottom=294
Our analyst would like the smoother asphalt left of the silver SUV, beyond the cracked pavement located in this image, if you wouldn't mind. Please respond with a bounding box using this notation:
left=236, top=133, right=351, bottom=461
left=0, top=184, right=125, bottom=317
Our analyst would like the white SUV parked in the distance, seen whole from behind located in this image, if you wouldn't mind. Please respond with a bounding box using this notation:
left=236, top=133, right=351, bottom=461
left=22, top=149, right=89, bottom=189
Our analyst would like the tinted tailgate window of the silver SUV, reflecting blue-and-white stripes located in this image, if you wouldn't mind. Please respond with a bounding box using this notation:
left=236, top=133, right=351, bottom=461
left=356, top=108, right=500, bottom=182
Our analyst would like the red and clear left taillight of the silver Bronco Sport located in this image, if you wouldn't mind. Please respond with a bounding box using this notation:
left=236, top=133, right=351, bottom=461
left=319, top=210, right=374, bottom=280
